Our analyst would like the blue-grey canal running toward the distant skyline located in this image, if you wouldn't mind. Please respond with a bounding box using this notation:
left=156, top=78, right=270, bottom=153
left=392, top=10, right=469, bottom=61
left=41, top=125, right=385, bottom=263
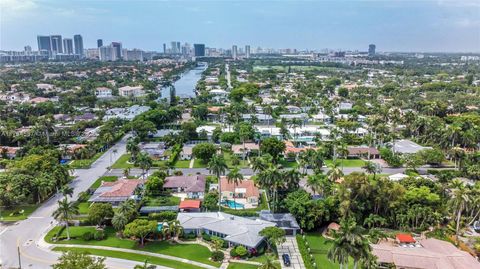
left=162, top=63, right=207, bottom=99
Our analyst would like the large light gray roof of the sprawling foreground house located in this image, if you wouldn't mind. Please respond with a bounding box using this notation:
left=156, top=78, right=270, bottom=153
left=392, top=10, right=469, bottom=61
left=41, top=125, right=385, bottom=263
left=177, top=212, right=275, bottom=248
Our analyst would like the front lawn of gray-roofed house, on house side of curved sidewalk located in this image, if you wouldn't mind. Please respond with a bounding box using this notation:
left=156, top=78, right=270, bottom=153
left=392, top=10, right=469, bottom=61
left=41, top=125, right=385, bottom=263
left=45, top=226, right=220, bottom=266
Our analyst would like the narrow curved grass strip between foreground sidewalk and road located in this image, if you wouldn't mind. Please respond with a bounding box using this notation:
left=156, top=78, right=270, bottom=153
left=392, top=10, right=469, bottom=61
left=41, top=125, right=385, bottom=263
left=53, top=247, right=202, bottom=269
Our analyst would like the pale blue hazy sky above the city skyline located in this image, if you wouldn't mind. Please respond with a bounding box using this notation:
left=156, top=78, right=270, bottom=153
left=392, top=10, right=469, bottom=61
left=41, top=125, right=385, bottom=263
left=0, top=0, right=480, bottom=52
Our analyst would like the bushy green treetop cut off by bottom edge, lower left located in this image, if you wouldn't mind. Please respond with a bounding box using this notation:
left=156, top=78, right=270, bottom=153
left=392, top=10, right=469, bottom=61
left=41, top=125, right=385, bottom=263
left=52, top=251, right=107, bottom=269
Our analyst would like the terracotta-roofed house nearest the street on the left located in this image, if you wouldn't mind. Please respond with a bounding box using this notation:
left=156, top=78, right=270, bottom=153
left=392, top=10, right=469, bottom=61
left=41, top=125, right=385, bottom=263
left=88, top=179, right=144, bottom=205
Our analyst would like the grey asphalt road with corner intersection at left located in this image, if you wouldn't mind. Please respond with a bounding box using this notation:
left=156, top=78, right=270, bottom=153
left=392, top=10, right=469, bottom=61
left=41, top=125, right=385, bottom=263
left=0, top=137, right=137, bottom=269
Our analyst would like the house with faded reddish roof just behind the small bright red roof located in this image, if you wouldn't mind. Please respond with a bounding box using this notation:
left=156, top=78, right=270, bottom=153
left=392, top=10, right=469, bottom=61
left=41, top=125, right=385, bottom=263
left=163, top=175, right=207, bottom=199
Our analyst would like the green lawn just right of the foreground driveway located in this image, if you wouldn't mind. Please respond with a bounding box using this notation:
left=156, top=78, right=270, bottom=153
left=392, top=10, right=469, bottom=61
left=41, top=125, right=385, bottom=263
left=297, top=232, right=353, bottom=269
